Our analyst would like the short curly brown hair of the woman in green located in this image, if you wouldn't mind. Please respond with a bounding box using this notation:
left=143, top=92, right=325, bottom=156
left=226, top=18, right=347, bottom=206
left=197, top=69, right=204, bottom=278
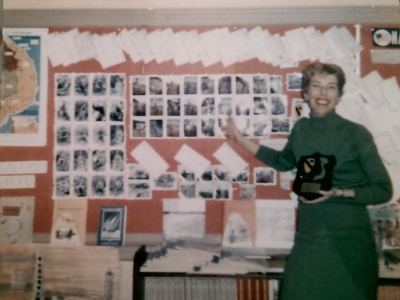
left=301, top=62, right=346, bottom=96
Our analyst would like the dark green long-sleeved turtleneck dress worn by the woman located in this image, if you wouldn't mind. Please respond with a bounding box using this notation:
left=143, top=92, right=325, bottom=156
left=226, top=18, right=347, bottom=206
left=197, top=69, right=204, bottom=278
left=256, top=111, right=392, bottom=300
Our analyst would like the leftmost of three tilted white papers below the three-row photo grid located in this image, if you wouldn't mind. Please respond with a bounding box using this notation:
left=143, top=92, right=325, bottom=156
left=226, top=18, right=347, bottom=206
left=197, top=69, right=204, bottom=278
left=131, top=142, right=169, bottom=178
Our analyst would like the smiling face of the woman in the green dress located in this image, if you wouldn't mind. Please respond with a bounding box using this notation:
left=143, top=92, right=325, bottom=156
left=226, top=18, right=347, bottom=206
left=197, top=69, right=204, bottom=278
left=304, top=74, right=340, bottom=117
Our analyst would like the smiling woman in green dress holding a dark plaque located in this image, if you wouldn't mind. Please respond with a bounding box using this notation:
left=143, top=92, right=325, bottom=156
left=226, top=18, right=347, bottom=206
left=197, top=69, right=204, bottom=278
left=225, top=63, right=392, bottom=300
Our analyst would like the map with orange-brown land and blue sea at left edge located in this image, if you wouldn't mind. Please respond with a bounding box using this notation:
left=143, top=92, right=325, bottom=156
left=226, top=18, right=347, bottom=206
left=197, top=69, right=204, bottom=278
left=0, top=28, right=47, bottom=146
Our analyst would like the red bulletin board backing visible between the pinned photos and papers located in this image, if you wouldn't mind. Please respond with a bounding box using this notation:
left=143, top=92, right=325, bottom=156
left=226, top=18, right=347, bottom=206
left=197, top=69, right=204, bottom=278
left=0, top=24, right=400, bottom=244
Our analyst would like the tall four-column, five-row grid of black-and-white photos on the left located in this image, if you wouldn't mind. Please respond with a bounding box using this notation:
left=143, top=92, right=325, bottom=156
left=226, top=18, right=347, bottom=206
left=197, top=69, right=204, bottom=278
left=53, top=73, right=126, bottom=198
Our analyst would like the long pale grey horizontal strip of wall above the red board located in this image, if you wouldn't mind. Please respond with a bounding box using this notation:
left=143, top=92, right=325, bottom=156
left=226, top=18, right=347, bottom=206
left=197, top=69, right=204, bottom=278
left=0, top=6, right=400, bottom=27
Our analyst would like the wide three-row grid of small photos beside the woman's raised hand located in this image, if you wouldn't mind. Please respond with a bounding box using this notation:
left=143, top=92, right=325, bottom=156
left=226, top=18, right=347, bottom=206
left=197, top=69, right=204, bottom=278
left=129, top=74, right=294, bottom=139
